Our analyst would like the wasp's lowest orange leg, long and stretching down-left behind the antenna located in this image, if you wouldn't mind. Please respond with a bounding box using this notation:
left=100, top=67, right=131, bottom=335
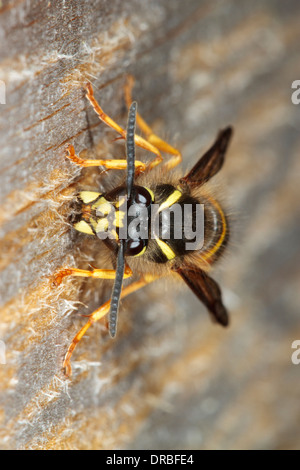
left=63, top=276, right=158, bottom=377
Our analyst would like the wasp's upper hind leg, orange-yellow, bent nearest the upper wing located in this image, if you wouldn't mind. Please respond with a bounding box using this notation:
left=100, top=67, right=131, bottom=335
left=124, top=75, right=182, bottom=170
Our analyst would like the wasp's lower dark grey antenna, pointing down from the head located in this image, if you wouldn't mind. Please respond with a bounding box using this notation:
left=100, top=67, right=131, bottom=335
left=109, top=240, right=125, bottom=338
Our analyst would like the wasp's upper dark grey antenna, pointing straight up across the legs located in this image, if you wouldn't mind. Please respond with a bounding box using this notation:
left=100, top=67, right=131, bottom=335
left=126, top=101, right=137, bottom=200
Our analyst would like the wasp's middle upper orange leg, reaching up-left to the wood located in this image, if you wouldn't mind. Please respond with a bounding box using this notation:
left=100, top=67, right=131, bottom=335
left=86, top=83, right=162, bottom=168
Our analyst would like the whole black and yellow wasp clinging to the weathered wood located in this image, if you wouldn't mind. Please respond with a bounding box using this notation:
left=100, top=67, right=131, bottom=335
left=54, top=76, right=233, bottom=376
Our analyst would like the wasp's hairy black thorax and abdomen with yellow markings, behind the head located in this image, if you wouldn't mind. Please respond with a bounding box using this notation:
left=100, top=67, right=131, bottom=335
left=146, top=184, right=229, bottom=264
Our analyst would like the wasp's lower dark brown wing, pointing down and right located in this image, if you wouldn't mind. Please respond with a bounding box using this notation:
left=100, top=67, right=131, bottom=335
left=173, top=265, right=229, bottom=326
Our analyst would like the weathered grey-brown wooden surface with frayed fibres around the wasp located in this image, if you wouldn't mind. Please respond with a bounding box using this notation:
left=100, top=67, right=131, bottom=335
left=0, top=0, right=300, bottom=449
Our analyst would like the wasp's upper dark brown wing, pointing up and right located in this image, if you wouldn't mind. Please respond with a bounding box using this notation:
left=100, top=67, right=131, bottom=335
left=180, top=127, right=233, bottom=186
